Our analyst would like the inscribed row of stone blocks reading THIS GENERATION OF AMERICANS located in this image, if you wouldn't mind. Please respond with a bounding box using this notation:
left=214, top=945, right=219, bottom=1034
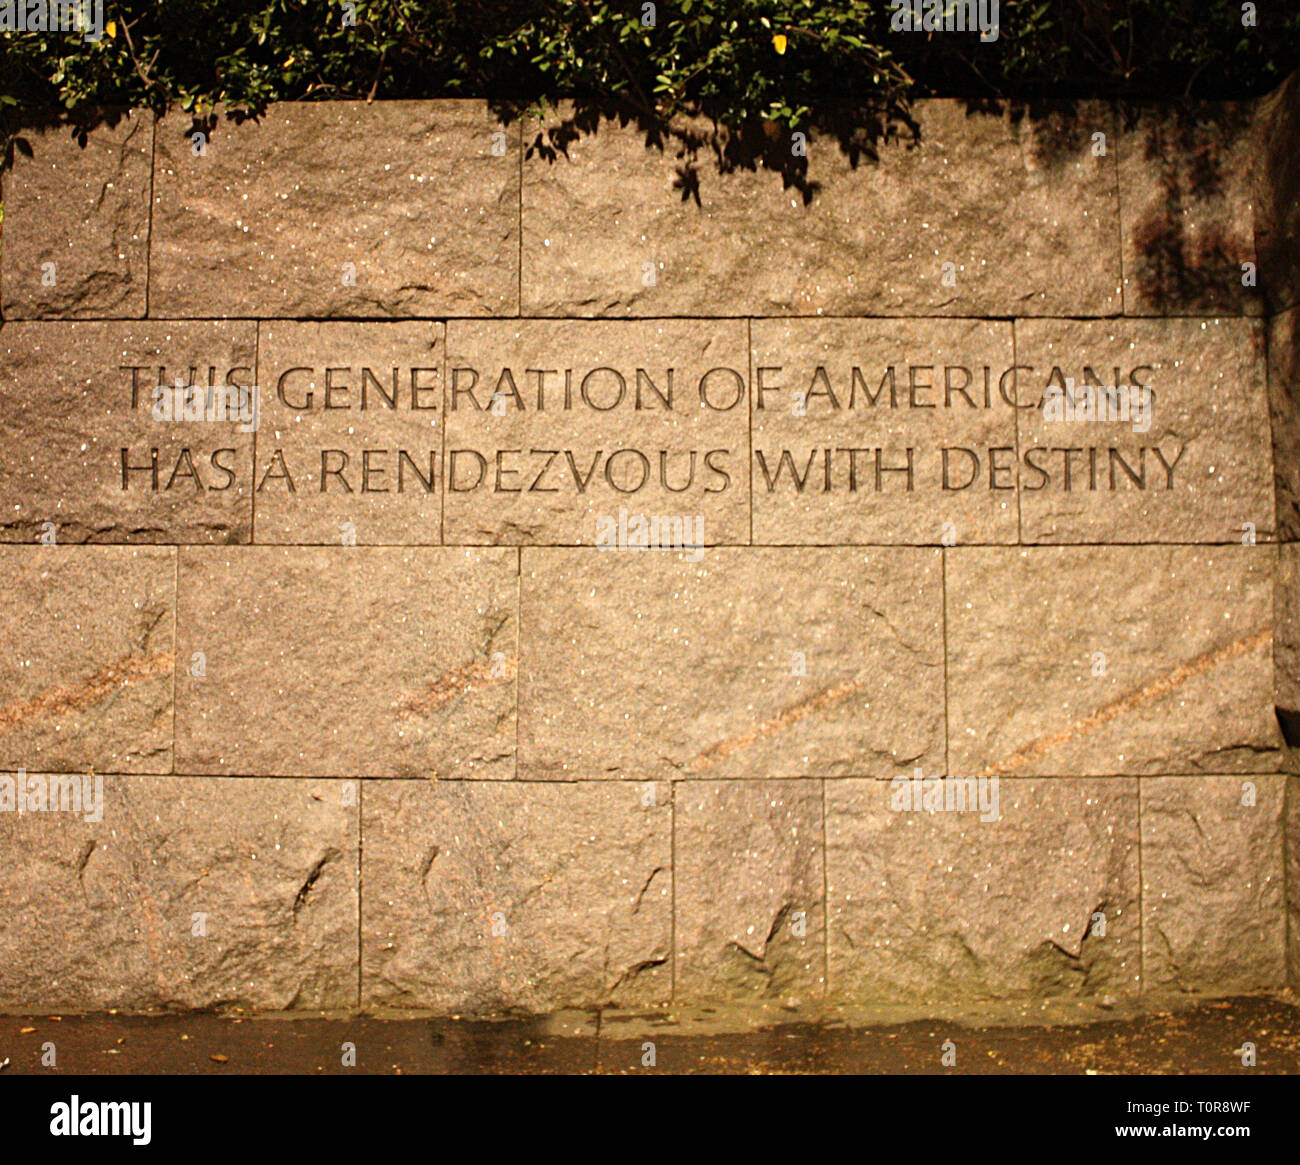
left=5, top=321, right=1271, bottom=545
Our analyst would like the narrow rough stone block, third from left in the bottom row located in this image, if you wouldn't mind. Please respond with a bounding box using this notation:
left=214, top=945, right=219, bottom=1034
left=673, top=780, right=826, bottom=1002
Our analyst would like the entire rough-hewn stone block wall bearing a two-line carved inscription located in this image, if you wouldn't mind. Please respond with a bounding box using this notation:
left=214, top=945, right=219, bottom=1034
left=0, top=85, right=1300, bottom=1013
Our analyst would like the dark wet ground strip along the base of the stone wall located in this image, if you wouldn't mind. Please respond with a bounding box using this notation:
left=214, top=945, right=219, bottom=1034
left=0, top=992, right=1300, bottom=1075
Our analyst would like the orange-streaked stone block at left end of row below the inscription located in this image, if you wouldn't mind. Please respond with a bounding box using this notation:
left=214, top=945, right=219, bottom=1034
left=0, top=546, right=176, bottom=772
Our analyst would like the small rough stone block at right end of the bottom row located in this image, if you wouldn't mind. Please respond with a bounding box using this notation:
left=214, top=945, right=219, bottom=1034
left=1141, top=776, right=1287, bottom=995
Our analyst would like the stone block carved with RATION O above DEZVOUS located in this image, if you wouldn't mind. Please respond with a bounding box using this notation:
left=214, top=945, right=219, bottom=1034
left=446, top=320, right=749, bottom=546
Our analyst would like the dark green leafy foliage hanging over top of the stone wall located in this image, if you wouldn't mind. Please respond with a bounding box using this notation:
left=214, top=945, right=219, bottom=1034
left=0, top=0, right=1300, bottom=127
